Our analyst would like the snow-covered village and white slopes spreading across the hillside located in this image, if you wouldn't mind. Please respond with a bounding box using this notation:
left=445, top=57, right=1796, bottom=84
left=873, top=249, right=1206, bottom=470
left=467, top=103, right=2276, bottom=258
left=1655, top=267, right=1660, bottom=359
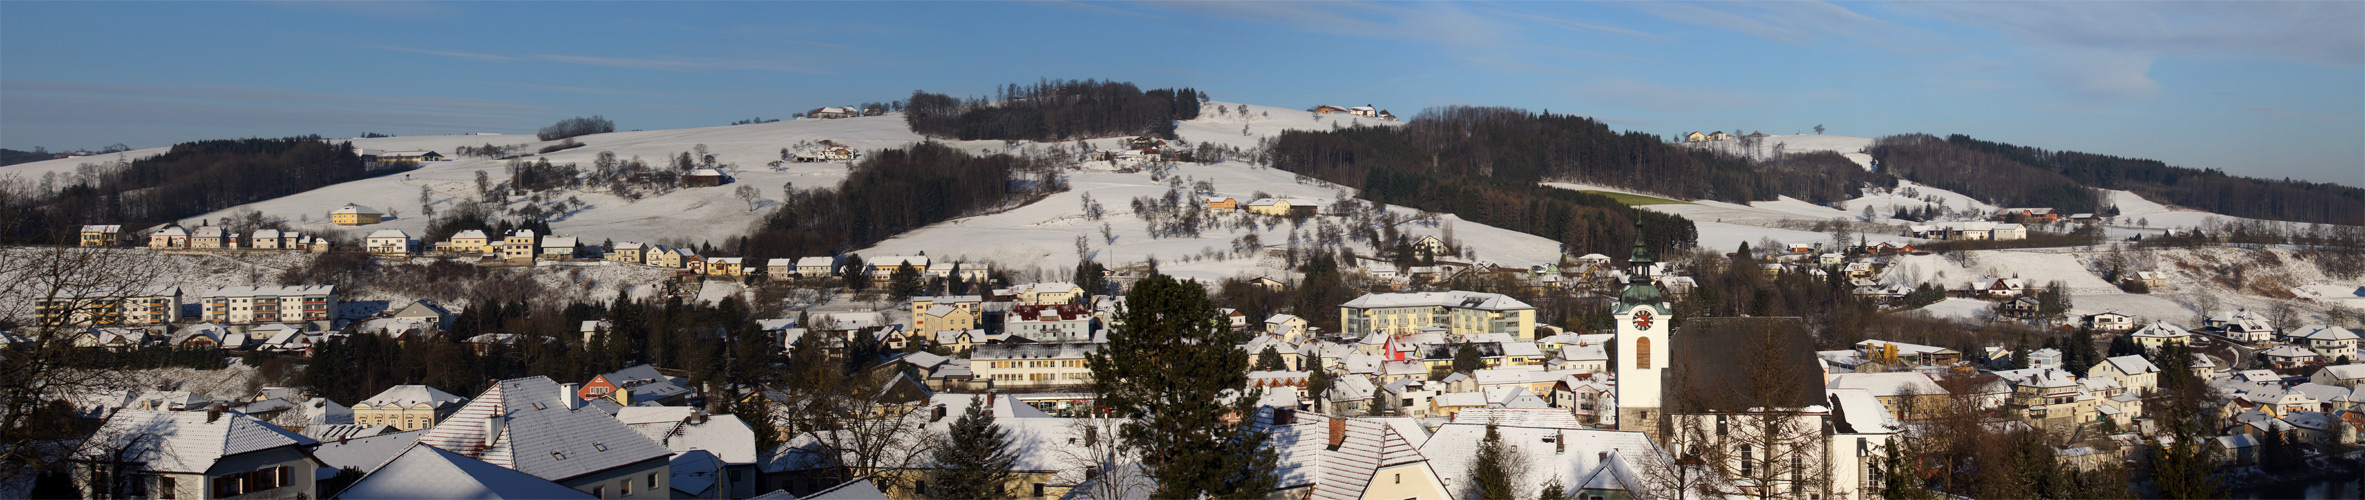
left=0, top=97, right=2365, bottom=500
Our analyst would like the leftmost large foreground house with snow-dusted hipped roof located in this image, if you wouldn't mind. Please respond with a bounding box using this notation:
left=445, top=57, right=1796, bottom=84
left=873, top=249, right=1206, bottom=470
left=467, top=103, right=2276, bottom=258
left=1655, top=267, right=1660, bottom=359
left=69, top=405, right=322, bottom=498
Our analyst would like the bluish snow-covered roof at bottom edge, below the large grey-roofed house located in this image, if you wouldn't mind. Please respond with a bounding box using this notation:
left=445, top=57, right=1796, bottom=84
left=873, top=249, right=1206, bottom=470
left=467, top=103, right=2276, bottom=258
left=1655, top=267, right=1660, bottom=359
left=336, top=445, right=591, bottom=500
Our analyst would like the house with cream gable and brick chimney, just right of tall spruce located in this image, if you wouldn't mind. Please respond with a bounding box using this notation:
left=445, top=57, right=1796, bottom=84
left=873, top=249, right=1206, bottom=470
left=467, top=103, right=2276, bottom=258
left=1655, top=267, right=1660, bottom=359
left=1253, top=408, right=1454, bottom=500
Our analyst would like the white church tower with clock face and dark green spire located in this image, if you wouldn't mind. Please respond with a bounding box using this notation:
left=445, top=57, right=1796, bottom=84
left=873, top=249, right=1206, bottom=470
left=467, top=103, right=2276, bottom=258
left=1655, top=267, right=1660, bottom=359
left=1611, top=220, right=1674, bottom=438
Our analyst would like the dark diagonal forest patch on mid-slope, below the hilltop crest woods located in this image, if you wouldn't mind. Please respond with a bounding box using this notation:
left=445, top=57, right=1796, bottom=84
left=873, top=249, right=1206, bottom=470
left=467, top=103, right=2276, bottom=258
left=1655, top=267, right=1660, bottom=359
left=743, top=142, right=1064, bottom=258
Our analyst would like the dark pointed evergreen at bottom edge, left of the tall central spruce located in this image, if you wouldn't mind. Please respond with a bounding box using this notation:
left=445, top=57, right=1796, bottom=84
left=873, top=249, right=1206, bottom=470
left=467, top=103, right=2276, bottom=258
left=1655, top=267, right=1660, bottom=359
left=927, top=398, right=1019, bottom=498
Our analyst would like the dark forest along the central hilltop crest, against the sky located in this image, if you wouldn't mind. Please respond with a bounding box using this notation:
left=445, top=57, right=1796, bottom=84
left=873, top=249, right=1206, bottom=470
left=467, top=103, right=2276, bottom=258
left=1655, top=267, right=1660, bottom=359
left=903, top=81, right=1206, bottom=142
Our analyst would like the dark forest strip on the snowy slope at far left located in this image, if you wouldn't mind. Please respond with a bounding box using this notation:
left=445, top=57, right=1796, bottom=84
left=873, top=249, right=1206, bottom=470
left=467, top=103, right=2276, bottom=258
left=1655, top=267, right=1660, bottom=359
left=0, top=135, right=383, bottom=244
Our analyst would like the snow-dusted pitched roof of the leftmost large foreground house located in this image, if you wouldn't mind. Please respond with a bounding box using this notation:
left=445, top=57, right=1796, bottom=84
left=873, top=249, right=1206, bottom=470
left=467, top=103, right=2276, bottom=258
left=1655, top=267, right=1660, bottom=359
left=76, top=410, right=319, bottom=474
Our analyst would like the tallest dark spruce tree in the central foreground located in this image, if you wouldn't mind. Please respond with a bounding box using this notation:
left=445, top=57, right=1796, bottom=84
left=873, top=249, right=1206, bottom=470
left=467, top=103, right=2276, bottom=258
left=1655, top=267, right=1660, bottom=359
left=1086, top=275, right=1279, bottom=498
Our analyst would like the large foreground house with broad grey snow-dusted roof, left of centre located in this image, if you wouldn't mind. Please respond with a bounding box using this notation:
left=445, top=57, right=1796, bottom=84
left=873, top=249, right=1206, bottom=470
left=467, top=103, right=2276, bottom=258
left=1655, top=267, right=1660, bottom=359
left=419, top=377, right=674, bottom=500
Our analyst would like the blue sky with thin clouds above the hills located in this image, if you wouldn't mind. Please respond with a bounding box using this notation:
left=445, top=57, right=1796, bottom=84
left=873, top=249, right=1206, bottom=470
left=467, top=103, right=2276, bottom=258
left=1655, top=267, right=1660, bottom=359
left=0, top=0, right=2365, bottom=185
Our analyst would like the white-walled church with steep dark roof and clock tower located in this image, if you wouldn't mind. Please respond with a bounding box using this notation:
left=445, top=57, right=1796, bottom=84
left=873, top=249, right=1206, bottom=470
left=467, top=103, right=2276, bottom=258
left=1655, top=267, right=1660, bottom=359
left=1611, top=225, right=1899, bottom=500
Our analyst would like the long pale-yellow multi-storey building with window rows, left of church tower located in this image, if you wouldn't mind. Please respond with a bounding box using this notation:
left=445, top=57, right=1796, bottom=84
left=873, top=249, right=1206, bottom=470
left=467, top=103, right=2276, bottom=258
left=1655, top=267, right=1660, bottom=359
left=1339, top=291, right=1535, bottom=341
